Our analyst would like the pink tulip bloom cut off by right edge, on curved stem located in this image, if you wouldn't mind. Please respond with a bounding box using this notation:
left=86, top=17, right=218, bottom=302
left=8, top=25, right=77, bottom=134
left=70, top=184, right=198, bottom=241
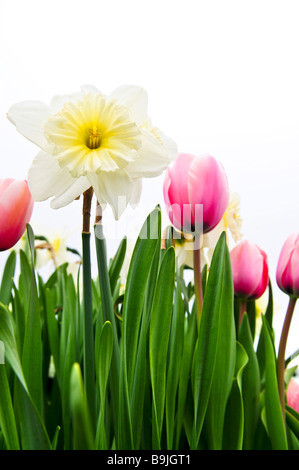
left=276, top=233, right=299, bottom=297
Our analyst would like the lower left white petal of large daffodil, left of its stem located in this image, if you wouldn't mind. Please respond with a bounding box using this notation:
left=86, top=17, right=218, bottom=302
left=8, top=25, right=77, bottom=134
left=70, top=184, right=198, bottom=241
left=28, top=152, right=90, bottom=208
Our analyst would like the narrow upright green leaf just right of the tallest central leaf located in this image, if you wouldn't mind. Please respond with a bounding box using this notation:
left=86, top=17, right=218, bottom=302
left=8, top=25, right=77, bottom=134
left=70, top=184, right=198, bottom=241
left=149, top=247, right=175, bottom=449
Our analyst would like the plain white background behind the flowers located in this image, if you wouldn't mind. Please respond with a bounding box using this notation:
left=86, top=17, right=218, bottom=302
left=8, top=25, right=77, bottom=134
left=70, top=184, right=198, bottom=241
left=0, top=0, right=299, bottom=360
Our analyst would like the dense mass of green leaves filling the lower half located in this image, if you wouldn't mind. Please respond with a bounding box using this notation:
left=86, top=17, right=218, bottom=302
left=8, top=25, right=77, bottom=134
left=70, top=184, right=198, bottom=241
left=0, top=215, right=299, bottom=450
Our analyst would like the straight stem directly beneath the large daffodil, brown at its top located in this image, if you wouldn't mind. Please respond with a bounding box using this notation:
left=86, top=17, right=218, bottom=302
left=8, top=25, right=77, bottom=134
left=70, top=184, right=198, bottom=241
left=82, top=190, right=95, bottom=430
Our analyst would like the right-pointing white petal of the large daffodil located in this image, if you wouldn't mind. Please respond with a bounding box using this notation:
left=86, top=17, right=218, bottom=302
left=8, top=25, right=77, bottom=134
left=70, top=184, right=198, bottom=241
left=125, top=129, right=175, bottom=178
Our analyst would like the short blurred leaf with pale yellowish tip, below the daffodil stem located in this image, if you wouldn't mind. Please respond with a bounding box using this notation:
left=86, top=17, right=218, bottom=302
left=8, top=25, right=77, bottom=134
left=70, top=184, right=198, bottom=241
left=70, top=363, right=95, bottom=450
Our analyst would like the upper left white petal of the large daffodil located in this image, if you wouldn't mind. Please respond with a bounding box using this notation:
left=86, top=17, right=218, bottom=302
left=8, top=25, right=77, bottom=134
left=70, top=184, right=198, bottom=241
left=7, top=101, right=51, bottom=151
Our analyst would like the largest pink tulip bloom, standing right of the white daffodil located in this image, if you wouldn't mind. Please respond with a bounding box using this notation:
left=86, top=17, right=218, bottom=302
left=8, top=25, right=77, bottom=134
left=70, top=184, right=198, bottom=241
left=163, top=153, right=229, bottom=233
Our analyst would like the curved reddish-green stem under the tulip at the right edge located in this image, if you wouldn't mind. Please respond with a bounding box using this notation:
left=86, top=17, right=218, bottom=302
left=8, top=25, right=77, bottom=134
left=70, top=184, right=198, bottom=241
left=277, top=297, right=297, bottom=420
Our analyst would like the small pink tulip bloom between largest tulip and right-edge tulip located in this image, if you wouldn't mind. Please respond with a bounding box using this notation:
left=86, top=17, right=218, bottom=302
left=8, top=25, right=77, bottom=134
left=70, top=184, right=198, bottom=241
left=230, top=240, right=269, bottom=299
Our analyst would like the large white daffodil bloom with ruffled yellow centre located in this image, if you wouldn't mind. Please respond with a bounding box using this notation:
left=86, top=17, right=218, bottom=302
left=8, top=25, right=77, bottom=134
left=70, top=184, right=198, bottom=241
left=7, top=85, right=177, bottom=218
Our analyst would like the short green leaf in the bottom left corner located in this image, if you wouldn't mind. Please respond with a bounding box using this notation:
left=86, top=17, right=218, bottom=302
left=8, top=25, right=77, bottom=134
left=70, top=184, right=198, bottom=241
left=0, top=364, right=20, bottom=450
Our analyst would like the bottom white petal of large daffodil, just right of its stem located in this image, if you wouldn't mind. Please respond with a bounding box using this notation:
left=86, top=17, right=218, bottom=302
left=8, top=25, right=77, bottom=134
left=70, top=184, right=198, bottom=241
left=88, top=171, right=140, bottom=220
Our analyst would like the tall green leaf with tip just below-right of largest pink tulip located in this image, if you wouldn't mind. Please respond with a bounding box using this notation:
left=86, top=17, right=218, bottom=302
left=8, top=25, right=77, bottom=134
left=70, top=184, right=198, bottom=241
left=191, top=232, right=231, bottom=449
